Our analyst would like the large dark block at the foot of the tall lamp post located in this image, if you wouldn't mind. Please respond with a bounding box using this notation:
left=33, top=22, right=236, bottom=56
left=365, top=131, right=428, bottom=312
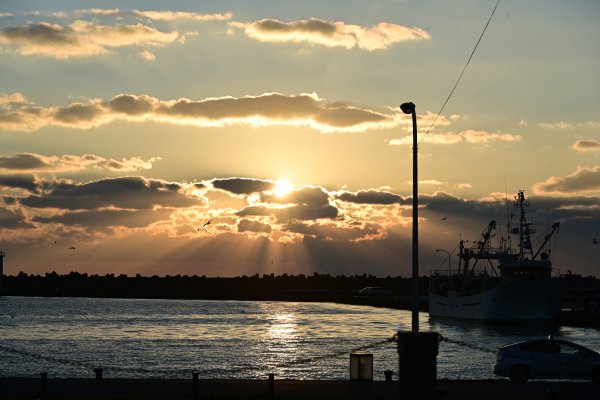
left=398, top=331, right=440, bottom=393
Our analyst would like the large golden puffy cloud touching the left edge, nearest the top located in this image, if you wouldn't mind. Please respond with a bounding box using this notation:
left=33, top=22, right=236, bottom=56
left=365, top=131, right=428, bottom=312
left=0, top=20, right=179, bottom=59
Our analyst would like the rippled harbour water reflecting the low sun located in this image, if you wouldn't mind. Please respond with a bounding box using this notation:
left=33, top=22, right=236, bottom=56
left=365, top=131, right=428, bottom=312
left=0, top=297, right=600, bottom=380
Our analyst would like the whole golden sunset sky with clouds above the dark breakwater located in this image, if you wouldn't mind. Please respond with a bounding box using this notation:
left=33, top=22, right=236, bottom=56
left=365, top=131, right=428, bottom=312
left=0, top=0, right=600, bottom=277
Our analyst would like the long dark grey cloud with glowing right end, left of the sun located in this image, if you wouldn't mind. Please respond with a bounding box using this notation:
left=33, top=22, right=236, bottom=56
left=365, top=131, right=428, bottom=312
left=11, top=177, right=202, bottom=210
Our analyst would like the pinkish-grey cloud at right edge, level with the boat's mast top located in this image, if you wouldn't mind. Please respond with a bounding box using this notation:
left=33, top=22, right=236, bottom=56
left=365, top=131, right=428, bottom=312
left=533, top=165, right=600, bottom=194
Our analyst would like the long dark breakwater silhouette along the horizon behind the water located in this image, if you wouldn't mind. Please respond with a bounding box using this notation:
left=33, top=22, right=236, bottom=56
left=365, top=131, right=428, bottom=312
left=0, top=272, right=600, bottom=327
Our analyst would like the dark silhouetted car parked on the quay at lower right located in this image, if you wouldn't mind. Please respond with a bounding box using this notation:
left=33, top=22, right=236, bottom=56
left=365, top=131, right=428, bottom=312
left=493, top=336, right=600, bottom=383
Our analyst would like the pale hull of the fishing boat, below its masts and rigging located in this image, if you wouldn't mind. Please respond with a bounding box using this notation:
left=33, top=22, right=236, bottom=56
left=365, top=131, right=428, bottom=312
left=429, top=278, right=561, bottom=321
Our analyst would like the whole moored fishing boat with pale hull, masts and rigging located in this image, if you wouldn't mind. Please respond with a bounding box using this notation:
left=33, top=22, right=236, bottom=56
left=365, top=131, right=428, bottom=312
left=428, top=191, right=562, bottom=322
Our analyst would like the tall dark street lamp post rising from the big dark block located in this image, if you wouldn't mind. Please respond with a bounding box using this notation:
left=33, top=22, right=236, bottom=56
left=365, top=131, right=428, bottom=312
left=400, top=102, right=420, bottom=332
